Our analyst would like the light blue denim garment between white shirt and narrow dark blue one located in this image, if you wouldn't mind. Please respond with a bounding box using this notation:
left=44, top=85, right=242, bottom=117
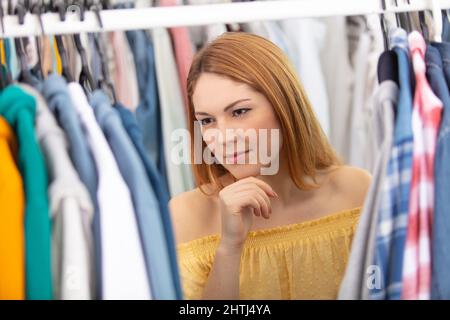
left=90, top=90, right=176, bottom=299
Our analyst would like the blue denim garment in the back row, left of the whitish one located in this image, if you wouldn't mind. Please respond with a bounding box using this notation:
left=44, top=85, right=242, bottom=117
left=126, top=30, right=169, bottom=198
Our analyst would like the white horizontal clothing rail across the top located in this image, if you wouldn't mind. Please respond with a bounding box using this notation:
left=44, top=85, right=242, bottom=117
left=0, top=0, right=450, bottom=38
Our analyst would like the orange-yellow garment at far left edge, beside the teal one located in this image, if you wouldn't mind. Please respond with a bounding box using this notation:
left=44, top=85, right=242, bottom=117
left=0, top=117, right=25, bottom=300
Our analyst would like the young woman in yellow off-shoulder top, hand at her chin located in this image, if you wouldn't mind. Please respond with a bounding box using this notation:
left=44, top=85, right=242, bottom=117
left=170, top=32, right=370, bottom=299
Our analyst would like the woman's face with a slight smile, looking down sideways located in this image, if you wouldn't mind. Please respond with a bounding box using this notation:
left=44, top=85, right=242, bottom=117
left=192, top=73, right=282, bottom=179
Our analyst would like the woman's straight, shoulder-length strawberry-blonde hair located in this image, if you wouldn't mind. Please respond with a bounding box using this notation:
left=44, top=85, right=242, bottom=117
left=187, top=32, right=341, bottom=194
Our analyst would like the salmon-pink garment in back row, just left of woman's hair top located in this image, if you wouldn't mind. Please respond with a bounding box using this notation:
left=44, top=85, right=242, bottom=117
left=160, top=0, right=194, bottom=115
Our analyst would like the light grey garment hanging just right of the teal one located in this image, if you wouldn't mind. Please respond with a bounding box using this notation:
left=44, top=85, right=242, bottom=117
left=21, top=85, right=94, bottom=300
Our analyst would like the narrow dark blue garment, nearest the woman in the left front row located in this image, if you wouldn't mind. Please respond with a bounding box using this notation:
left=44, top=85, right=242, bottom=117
left=115, top=104, right=183, bottom=300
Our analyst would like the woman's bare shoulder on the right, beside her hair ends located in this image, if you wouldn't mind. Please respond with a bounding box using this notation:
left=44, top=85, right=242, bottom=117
left=330, top=165, right=372, bottom=208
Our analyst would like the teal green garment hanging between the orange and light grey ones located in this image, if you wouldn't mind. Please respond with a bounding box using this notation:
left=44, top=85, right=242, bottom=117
left=0, top=85, right=52, bottom=300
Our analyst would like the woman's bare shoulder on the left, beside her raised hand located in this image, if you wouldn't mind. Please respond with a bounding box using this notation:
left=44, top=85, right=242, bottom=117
left=169, top=188, right=218, bottom=244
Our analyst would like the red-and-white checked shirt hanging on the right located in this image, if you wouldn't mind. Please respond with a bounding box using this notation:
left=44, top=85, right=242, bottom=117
left=402, top=31, right=442, bottom=300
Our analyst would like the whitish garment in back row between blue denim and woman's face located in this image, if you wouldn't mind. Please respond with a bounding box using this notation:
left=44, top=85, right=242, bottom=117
left=151, top=28, right=194, bottom=197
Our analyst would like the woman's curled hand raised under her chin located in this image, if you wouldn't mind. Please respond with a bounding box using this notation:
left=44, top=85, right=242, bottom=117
left=219, top=177, right=278, bottom=250
